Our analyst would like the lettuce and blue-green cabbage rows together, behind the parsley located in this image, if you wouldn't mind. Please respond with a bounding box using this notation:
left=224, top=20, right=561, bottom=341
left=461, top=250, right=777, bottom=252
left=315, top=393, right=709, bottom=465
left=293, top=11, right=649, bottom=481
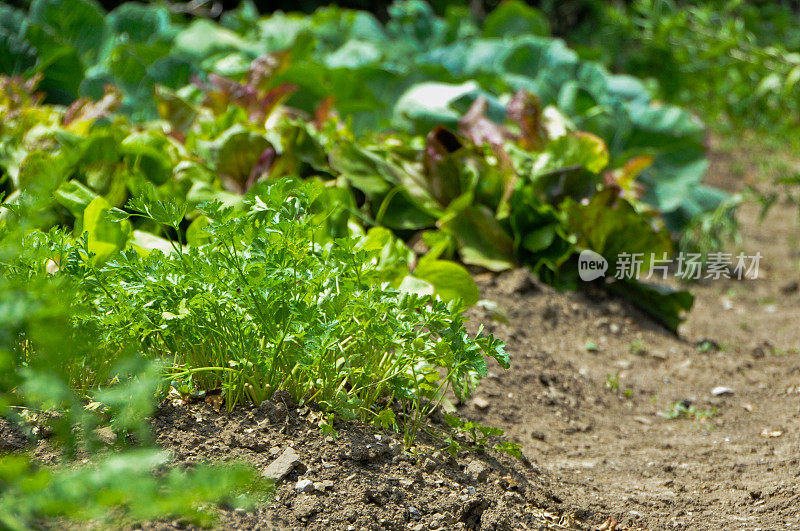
left=2, top=2, right=724, bottom=328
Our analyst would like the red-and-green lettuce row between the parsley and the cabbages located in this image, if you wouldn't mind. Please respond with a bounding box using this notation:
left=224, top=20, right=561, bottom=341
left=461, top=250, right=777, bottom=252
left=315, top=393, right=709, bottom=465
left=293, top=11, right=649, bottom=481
left=0, top=67, right=691, bottom=329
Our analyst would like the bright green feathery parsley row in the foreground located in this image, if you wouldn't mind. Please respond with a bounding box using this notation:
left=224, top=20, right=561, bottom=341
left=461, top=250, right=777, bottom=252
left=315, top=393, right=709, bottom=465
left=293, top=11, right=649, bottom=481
left=2, top=181, right=508, bottom=438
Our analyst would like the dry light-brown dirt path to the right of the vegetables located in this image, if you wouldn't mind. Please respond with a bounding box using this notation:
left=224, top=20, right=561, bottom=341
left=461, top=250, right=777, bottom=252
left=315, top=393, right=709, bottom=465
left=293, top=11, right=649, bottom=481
left=461, top=143, right=800, bottom=529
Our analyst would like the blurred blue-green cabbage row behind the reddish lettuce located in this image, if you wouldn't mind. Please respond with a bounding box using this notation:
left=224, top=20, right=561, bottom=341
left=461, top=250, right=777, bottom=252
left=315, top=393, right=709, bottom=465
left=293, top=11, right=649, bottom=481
left=0, top=0, right=724, bottom=230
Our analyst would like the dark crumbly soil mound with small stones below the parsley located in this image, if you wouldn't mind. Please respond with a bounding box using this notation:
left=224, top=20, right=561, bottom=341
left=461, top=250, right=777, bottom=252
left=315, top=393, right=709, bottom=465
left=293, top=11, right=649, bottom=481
left=147, top=399, right=577, bottom=530
